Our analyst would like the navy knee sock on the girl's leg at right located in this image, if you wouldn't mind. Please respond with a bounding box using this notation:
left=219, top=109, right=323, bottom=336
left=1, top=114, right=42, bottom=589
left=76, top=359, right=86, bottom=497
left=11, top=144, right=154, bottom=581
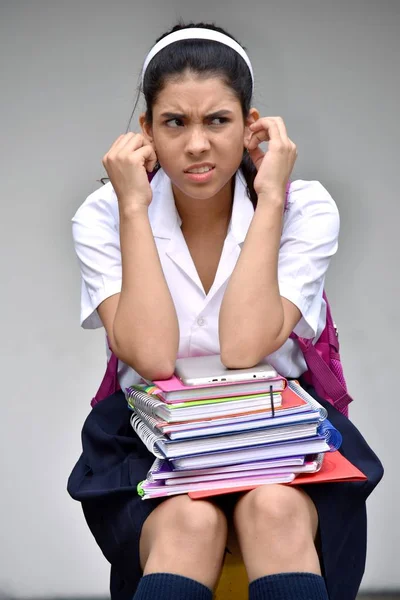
left=249, top=573, right=328, bottom=600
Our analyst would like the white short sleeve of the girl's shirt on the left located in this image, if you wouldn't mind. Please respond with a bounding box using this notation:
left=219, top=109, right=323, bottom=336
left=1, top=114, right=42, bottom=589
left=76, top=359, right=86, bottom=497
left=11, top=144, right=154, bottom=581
left=72, top=184, right=122, bottom=329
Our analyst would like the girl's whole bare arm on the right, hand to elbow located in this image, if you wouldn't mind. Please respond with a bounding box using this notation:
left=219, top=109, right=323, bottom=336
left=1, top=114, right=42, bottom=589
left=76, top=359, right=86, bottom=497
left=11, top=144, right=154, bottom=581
left=219, top=117, right=301, bottom=368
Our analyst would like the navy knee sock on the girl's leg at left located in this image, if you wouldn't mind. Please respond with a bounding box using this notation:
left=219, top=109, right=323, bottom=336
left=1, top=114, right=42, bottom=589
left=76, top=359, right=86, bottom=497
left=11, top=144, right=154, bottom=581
left=133, top=573, right=212, bottom=600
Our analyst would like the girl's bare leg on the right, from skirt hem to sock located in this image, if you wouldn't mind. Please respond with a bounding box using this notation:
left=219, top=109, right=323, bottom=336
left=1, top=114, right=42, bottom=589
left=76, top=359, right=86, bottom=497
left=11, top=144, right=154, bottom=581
left=234, top=485, right=321, bottom=582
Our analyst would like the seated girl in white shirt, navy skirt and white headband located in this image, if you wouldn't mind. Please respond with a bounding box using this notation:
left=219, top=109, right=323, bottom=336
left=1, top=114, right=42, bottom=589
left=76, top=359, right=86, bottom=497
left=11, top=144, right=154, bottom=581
left=68, top=23, right=382, bottom=600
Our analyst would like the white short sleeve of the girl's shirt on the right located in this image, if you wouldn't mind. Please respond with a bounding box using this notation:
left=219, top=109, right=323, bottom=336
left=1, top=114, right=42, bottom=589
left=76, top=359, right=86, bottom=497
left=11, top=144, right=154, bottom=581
left=278, top=180, right=340, bottom=339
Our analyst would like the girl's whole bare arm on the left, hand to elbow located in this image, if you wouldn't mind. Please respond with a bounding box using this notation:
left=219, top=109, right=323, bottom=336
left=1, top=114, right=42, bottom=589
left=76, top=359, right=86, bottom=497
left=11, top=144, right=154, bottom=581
left=98, top=133, right=179, bottom=380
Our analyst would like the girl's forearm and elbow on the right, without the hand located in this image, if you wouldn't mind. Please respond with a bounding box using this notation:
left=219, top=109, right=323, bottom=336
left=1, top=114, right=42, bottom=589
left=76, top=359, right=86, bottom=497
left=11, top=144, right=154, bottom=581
left=219, top=196, right=301, bottom=368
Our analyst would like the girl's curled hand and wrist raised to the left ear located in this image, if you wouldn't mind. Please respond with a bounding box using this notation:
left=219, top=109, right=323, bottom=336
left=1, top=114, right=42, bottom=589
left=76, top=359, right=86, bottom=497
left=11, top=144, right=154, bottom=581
left=102, top=132, right=157, bottom=209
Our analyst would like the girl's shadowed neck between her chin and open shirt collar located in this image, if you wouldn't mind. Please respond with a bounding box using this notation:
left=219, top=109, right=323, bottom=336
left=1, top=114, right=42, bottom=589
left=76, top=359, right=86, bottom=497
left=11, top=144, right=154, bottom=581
left=172, top=178, right=235, bottom=231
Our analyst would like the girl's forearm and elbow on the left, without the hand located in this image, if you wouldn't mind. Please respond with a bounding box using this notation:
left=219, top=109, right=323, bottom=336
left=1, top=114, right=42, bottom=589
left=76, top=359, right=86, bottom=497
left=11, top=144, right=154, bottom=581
left=98, top=207, right=179, bottom=380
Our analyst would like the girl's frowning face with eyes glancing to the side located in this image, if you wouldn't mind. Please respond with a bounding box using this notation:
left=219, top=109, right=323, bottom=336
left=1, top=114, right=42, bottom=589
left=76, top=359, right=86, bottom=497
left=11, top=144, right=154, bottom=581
left=140, top=74, right=258, bottom=200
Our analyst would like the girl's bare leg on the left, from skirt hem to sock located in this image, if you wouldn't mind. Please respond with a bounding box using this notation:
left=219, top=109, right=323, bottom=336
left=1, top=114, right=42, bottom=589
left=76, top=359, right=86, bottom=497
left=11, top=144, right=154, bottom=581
left=140, top=495, right=227, bottom=589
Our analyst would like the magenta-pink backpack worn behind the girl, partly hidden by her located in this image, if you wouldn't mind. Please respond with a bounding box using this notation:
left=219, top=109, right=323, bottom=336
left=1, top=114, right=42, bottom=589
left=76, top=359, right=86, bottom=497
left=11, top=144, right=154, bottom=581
left=91, top=184, right=353, bottom=417
